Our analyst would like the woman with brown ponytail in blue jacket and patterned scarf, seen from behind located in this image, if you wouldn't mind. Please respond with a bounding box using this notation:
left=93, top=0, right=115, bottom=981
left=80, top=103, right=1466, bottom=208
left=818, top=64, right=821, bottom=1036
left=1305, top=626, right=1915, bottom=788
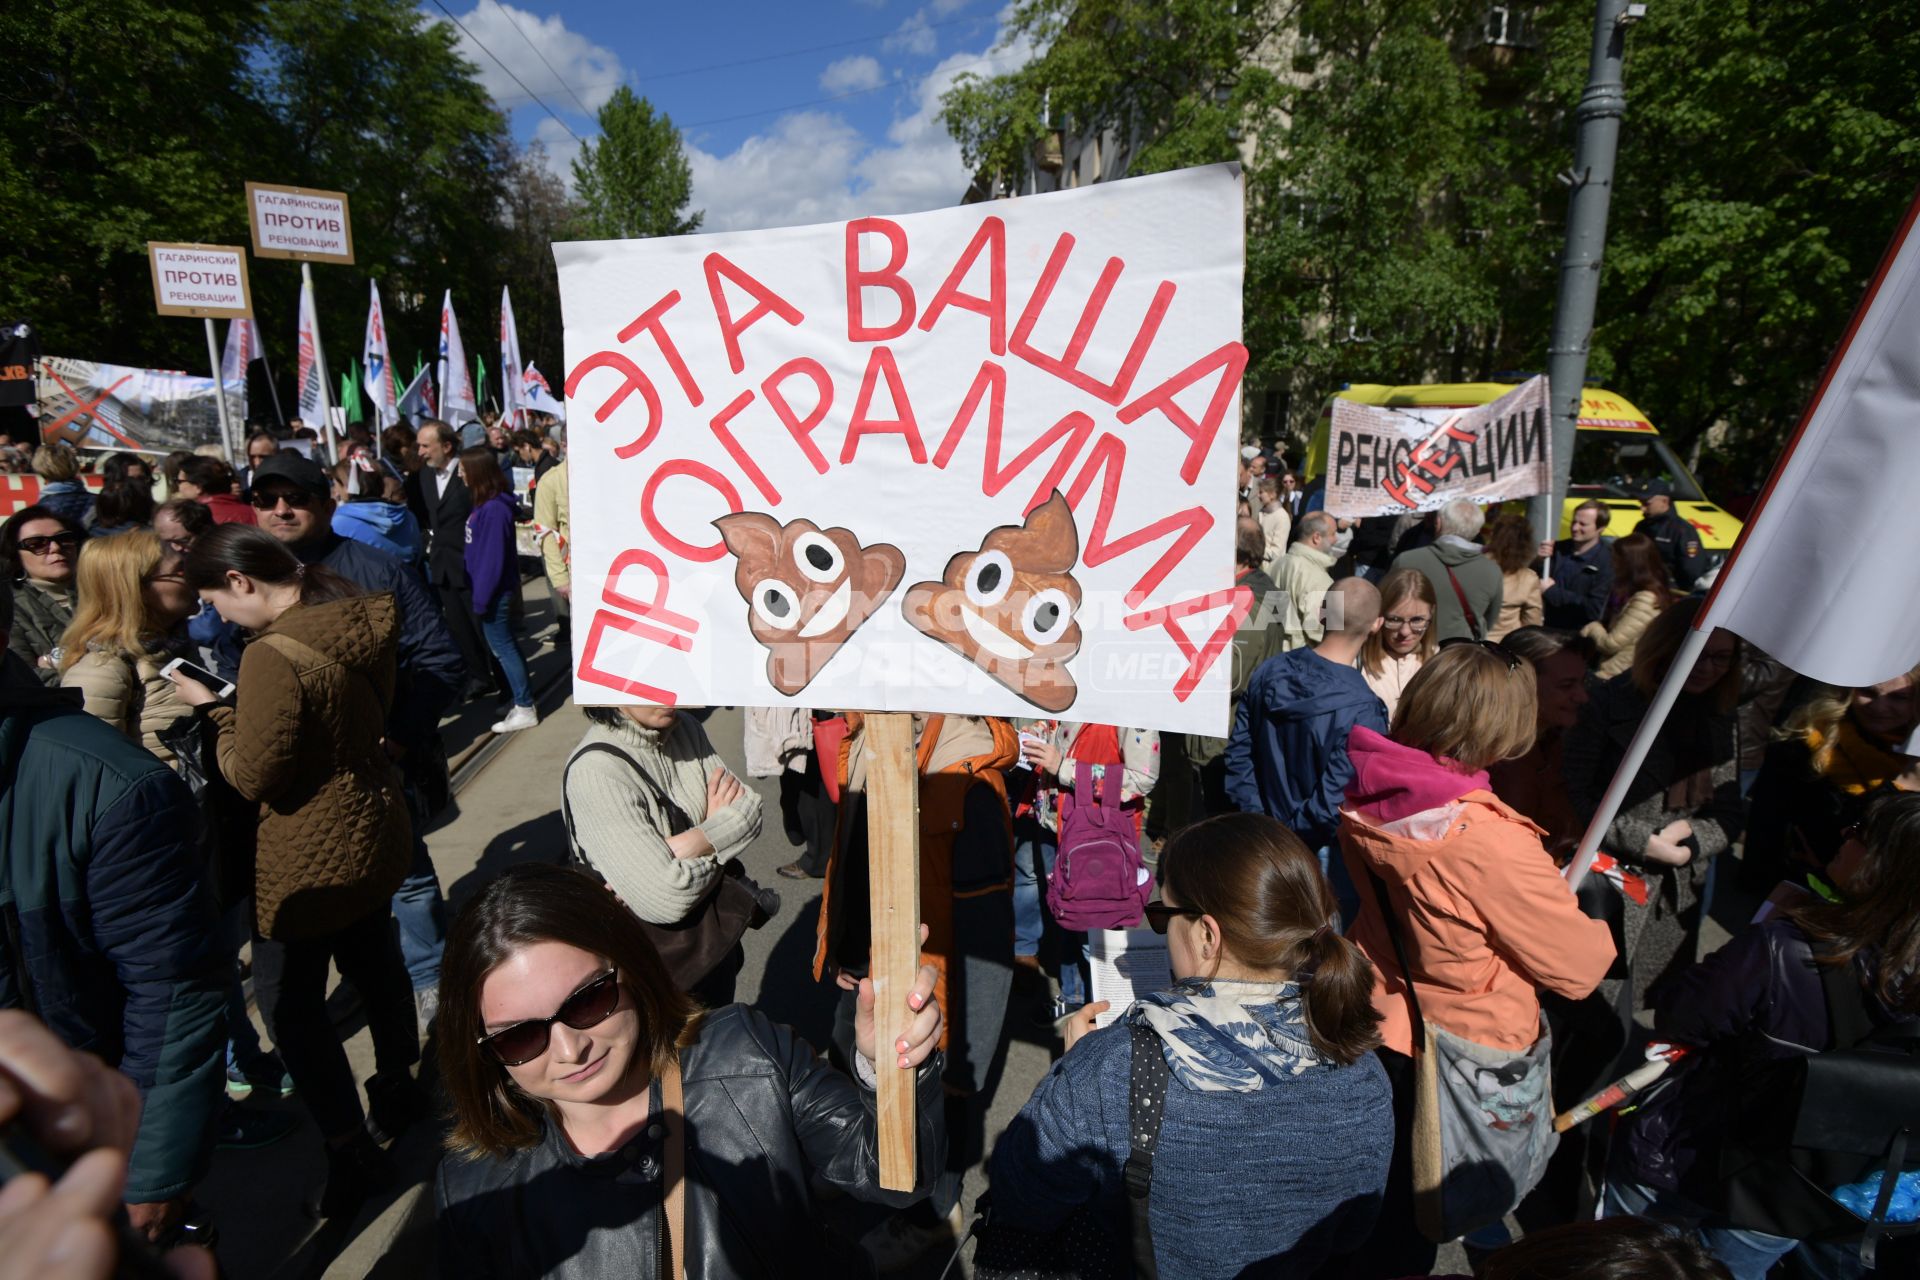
left=991, top=814, right=1392, bottom=1276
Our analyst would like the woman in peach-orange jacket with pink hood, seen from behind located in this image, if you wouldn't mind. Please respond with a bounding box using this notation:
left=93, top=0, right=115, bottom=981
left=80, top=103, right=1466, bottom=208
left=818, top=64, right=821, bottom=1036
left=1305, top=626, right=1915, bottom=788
left=1340, top=639, right=1613, bottom=1280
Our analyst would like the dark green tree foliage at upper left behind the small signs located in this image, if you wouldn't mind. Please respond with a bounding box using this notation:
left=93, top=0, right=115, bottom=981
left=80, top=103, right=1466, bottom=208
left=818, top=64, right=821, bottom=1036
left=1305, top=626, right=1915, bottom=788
left=0, top=0, right=629, bottom=409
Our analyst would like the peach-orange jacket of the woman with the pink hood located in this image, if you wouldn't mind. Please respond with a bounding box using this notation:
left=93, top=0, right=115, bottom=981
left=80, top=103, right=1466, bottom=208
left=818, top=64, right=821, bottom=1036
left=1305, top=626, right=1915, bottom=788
left=1340, top=791, right=1613, bottom=1054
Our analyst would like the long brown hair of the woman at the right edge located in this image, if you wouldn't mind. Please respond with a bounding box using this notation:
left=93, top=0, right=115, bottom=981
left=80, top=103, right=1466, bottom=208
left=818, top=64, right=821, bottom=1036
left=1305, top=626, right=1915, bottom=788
left=1786, top=791, right=1920, bottom=1013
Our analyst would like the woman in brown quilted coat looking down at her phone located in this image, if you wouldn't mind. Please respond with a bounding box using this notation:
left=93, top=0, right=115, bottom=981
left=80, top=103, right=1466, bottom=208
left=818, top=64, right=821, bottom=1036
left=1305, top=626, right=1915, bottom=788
left=175, top=524, right=426, bottom=1217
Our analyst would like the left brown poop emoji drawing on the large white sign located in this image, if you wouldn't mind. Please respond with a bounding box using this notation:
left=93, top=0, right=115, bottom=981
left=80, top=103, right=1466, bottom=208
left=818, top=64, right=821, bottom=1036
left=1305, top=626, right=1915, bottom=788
left=714, top=510, right=906, bottom=697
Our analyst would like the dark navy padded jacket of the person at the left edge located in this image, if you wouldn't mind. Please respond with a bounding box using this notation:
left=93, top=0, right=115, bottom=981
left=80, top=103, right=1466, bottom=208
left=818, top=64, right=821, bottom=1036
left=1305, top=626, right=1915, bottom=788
left=0, top=654, right=232, bottom=1203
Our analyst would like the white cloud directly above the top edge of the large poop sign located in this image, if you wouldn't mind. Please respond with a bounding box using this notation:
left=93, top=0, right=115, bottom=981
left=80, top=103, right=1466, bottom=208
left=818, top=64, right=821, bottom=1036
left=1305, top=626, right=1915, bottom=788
left=687, top=21, right=1033, bottom=230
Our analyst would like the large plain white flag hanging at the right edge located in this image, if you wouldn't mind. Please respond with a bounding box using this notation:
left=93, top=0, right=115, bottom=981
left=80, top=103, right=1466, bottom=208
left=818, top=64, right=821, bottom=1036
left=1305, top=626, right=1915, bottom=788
left=1695, top=200, right=1920, bottom=689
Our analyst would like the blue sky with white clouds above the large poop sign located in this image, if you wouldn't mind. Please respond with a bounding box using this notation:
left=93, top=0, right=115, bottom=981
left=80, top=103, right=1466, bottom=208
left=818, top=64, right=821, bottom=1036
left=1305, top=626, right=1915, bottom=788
left=433, top=0, right=1027, bottom=230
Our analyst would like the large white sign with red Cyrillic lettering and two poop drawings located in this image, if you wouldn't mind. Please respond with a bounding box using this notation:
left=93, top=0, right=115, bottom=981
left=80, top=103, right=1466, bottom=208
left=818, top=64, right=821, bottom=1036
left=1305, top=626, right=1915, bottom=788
left=555, top=165, right=1252, bottom=735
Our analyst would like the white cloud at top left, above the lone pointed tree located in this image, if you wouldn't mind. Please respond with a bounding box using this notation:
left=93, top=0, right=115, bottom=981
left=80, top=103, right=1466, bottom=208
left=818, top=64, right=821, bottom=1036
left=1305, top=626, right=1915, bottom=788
left=439, top=0, right=626, bottom=119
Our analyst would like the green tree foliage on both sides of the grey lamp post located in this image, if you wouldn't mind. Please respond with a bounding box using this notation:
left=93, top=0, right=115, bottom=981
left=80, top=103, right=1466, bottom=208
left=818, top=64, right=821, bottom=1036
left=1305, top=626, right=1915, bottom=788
left=943, top=0, right=1920, bottom=482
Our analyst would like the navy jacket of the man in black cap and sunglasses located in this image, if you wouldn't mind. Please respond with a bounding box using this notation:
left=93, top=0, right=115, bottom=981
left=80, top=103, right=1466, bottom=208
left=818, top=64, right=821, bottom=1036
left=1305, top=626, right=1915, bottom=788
left=294, top=530, right=465, bottom=748
